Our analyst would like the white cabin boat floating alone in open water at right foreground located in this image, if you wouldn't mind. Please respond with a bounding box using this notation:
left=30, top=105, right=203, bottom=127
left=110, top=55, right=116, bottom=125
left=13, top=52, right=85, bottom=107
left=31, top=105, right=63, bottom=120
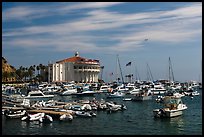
left=153, top=96, right=187, bottom=118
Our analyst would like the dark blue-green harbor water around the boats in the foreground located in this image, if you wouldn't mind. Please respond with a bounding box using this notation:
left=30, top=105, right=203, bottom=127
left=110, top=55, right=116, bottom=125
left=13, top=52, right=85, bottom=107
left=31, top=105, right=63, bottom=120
left=2, top=91, right=202, bottom=135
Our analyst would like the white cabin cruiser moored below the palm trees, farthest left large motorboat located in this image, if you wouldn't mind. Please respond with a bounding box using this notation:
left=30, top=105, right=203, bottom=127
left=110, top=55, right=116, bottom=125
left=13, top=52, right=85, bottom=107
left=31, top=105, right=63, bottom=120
left=24, top=90, right=54, bottom=99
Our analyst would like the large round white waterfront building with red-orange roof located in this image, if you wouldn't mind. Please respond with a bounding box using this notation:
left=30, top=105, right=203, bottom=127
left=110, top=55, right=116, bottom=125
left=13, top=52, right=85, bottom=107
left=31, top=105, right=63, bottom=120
left=48, top=52, right=100, bottom=83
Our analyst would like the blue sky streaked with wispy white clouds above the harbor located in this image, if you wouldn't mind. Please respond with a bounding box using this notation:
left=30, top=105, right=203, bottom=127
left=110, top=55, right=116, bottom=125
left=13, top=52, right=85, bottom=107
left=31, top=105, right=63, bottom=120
left=2, top=2, right=202, bottom=82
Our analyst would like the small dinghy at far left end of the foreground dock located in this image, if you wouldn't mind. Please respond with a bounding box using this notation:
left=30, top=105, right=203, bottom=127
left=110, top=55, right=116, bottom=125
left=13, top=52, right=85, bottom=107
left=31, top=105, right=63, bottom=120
left=4, top=110, right=26, bottom=118
